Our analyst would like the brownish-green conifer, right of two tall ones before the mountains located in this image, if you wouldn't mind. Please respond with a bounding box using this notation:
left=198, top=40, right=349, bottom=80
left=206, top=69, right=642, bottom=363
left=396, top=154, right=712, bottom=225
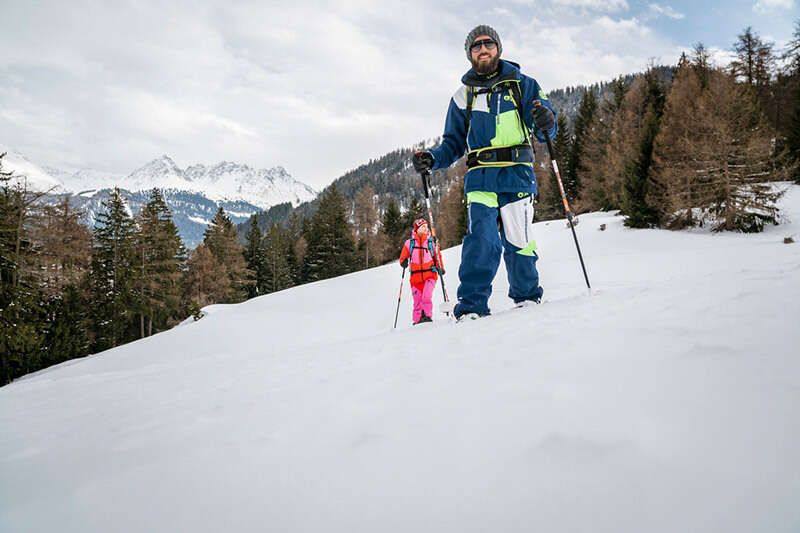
left=136, top=189, right=186, bottom=337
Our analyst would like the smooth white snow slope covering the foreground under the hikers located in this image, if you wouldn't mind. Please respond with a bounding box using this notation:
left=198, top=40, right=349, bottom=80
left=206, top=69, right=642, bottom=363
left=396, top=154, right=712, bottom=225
left=0, top=186, right=800, bottom=533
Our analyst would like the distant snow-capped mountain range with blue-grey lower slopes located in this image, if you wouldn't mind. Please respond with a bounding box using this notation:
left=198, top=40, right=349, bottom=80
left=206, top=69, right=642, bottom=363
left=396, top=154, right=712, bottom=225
left=0, top=146, right=317, bottom=248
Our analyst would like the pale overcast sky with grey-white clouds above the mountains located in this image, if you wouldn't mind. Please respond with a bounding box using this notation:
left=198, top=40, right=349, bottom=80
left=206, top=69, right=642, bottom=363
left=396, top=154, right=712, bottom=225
left=0, top=0, right=800, bottom=189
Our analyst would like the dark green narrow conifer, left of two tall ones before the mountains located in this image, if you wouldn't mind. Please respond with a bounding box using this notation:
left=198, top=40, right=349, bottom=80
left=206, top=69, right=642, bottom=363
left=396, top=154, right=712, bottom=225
left=91, top=189, right=138, bottom=351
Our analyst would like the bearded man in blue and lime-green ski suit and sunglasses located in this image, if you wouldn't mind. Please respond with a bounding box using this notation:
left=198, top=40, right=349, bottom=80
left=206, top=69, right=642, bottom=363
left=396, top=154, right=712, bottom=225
left=412, top=25, right=556, bottom=320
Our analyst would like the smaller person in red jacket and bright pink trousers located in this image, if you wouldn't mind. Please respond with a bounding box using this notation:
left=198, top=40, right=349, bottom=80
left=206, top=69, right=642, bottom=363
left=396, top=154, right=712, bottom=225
left=400, top=218, right=444, bottom=324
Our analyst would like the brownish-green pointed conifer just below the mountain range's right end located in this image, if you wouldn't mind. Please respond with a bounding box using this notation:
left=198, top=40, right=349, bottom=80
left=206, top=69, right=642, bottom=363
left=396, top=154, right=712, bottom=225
left=203, top=207, right=250, bottom=303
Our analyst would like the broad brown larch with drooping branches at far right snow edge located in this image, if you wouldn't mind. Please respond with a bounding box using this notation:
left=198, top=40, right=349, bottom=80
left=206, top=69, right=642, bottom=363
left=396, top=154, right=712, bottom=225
left=654, top=58, right=784, bottom=231
